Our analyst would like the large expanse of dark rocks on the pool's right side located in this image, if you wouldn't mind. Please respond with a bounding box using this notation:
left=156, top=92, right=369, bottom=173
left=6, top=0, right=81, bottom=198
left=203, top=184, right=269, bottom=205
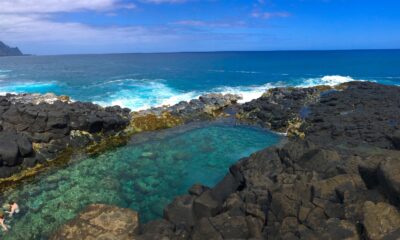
left=139, top=82, right=400, bottom=239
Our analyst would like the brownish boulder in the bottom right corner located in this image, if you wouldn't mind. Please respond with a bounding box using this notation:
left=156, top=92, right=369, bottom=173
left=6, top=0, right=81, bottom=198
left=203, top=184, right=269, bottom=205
left=363, top=201, right=400, bottom=240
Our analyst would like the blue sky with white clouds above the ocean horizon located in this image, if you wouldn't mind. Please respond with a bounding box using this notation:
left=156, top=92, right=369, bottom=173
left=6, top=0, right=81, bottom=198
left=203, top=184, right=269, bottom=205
left=0, top=0, right=400, bottom=55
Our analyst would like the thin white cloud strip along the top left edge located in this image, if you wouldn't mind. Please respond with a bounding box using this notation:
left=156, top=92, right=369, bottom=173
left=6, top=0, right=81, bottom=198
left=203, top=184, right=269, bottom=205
left=0, top=0, right=135, bottom=14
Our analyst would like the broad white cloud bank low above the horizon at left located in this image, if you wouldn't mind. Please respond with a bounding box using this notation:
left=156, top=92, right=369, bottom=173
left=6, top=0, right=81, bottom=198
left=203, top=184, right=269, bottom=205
left=0, top=14, right=177, bottom=53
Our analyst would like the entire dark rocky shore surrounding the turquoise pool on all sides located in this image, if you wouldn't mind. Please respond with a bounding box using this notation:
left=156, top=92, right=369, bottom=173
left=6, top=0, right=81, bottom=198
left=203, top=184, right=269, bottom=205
left=0, top=82, right=400, bottom=239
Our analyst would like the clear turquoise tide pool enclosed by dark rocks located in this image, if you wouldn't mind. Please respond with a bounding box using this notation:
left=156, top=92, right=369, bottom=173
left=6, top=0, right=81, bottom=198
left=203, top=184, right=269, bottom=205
left=2, top=123, right=279, bottom=239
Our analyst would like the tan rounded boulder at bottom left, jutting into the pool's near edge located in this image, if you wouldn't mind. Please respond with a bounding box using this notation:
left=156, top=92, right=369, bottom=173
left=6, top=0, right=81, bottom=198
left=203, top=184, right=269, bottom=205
left=51, top=204, right=140, bottom=240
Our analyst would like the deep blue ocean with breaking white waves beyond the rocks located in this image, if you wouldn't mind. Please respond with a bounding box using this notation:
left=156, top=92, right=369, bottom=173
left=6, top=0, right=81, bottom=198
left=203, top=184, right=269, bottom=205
left=0, top=50, right=400, bottom=110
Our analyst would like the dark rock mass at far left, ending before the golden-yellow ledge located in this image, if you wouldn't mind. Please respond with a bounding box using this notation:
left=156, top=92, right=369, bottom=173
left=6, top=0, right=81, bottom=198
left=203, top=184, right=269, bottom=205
left=0, top=94, right=129, bottom=178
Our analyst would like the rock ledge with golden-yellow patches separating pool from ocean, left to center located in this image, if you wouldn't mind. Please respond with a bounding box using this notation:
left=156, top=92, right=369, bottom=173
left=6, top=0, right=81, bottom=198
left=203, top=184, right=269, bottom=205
left=0, top=91, right=239, bottom=189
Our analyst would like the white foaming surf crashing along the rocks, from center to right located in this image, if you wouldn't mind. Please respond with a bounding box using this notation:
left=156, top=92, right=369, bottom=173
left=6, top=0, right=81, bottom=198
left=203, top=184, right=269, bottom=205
left=96, top=74, right=364, bottom=111
